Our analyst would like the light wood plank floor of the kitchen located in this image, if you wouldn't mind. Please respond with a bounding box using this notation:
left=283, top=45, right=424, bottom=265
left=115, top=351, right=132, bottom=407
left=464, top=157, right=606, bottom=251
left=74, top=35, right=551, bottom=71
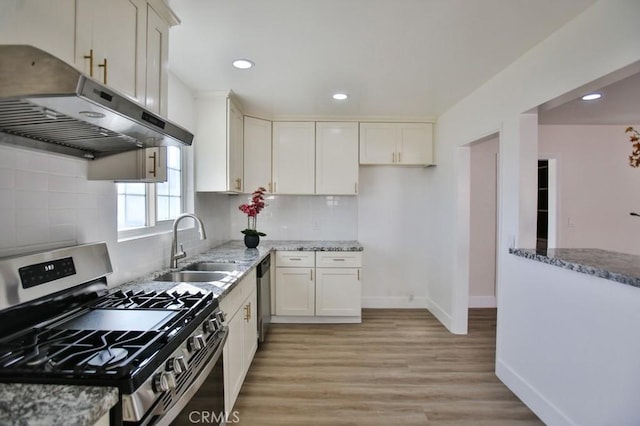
left=234, top=309, right=542, bottom=426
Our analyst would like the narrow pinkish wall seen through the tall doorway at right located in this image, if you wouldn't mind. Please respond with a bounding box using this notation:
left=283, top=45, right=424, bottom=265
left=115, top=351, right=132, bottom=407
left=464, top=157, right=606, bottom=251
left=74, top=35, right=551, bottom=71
left=469, top=138, right=499, bottom=308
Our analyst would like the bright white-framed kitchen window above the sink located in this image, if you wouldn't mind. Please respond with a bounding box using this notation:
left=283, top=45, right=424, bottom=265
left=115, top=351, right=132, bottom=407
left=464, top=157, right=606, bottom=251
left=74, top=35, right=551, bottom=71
left=117, top=146, right=184, bottom=239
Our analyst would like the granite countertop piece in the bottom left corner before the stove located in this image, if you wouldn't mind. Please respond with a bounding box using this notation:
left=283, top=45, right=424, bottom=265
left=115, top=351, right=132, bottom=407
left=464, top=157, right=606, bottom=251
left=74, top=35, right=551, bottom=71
left=0, top=383, right=118, bottom=426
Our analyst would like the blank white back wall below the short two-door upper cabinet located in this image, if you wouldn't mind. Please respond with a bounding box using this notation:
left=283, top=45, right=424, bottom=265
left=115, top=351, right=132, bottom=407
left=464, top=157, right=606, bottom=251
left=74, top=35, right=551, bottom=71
left=358, top=166, right=432, bottom=308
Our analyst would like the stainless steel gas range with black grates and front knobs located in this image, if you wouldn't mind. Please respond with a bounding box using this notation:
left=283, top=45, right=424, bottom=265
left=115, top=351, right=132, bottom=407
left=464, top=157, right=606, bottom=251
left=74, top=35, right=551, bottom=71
left=0, top=243, right=227, bottom=425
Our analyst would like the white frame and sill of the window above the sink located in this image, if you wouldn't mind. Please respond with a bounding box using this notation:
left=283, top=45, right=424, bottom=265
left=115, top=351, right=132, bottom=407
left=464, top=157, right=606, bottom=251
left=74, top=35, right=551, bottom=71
left=116, top=149, right=187, bottom=242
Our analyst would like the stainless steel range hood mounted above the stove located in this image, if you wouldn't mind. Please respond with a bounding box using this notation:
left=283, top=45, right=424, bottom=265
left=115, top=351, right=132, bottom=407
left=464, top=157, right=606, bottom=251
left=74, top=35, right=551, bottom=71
left=0, top=45, right=193, bottom=158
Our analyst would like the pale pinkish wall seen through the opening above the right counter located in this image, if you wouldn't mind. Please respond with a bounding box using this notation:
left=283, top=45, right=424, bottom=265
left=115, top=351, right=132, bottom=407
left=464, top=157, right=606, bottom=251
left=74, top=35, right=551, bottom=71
left=538, top=123, right=640, bottom=254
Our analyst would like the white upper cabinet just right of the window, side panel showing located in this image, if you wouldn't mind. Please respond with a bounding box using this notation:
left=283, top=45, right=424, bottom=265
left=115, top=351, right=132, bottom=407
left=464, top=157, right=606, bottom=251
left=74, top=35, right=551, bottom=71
left=193, top=92, right=244, bottom=193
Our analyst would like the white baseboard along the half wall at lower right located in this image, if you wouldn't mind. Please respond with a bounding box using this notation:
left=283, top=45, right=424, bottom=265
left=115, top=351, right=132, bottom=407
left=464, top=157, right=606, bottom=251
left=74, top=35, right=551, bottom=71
left=496, top=359, right=576, bottom=426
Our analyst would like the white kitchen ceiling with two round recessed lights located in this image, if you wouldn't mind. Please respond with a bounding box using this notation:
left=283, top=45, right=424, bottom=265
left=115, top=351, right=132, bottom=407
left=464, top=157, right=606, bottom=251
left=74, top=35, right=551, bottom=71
left=169, top=0, right=595, bottom=118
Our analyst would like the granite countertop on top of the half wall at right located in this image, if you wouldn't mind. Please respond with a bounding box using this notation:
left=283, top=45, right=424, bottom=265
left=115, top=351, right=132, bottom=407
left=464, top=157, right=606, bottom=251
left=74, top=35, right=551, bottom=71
left=509, top=248, right=640, bottom=287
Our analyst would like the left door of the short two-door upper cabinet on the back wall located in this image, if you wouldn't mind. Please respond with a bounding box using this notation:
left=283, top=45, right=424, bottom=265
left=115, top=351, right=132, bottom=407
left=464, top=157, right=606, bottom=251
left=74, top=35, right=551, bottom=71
left=360, top=123, right=397, bottom=164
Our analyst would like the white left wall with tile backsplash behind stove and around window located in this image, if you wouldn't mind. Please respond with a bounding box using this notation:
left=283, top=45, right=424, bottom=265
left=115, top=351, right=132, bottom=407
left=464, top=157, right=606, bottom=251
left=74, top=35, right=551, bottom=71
left=0, top=73, right=229, bottom=286
